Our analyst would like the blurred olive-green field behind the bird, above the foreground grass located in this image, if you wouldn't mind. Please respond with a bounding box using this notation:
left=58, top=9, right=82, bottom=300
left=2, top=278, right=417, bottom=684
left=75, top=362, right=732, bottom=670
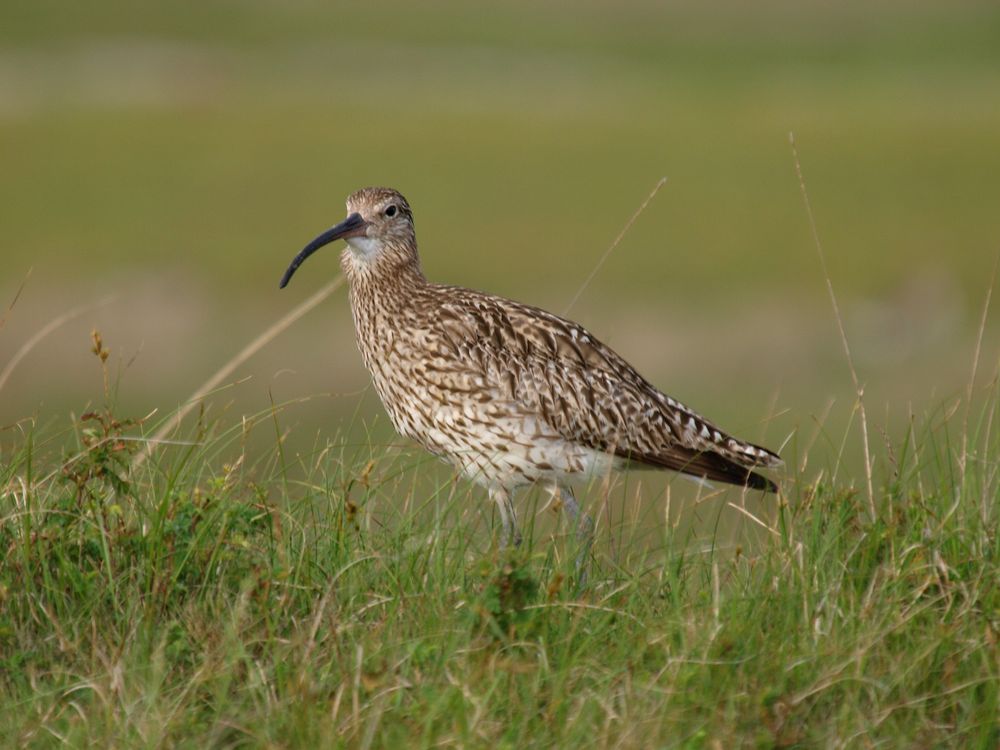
left=0, top=0, right=1000, bottom=476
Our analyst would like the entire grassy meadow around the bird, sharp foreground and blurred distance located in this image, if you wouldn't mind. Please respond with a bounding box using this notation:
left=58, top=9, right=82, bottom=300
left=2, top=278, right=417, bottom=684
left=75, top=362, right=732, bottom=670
left=0, top=0, right=1000, bottom=748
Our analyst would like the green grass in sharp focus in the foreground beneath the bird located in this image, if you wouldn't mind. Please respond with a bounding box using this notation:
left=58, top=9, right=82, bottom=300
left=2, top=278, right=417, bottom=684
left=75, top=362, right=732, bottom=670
left=0, top=340, right=1000, bottom=748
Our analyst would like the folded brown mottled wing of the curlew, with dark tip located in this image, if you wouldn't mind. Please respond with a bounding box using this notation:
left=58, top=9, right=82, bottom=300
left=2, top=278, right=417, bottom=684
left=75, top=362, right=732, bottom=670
left=437, top=287, right=781, bottom=489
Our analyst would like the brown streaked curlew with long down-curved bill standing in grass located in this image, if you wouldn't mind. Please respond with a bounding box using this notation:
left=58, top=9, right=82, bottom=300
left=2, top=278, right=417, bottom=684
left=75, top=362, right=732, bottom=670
left=280, top=187, right=782, bottom=565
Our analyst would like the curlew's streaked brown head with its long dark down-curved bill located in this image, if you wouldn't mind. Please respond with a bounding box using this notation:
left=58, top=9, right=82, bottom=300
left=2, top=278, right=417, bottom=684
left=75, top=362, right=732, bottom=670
left=280, top=187, right=417, bottom=288
